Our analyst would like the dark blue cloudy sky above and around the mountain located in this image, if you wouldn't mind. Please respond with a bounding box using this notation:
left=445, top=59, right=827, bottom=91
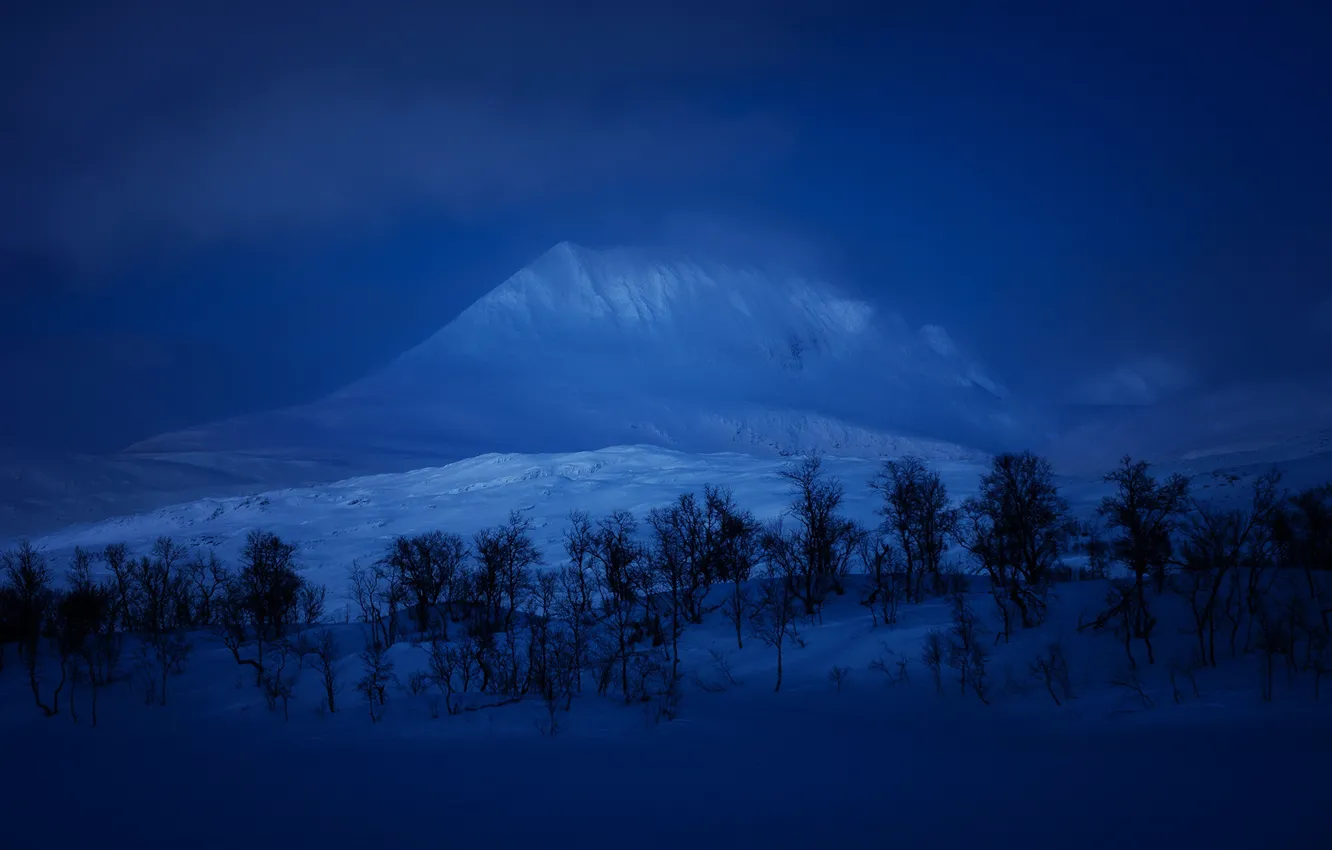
left=0, top=0, right=1332, bottom=450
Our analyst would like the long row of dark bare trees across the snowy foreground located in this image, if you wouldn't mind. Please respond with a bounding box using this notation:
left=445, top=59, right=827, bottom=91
left=0, top=453, right=1332, bottom=733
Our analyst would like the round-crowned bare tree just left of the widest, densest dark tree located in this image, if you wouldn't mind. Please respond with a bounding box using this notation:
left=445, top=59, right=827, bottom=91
left=870, top=456, right=958, bottom=601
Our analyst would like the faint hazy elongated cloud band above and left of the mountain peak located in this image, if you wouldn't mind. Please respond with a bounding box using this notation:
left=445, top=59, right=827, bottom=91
left=36, top=84, right=781, bottom=267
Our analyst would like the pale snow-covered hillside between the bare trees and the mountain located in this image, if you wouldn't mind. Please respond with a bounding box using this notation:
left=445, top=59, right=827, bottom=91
left=23, top=446, right=983, bottom=596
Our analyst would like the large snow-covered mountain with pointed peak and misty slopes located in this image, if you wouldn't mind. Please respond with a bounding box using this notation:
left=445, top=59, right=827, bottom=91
left=136, top=242, right=1023, bottom=460
